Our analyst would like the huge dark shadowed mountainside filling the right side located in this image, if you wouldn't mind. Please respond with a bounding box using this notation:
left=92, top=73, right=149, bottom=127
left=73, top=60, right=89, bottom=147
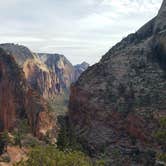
left=69, top=0, right=166, bottom=161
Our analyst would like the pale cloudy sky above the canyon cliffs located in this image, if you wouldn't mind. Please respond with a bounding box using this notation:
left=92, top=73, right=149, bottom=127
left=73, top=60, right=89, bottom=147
left=0, top=0, right=162, bottom=64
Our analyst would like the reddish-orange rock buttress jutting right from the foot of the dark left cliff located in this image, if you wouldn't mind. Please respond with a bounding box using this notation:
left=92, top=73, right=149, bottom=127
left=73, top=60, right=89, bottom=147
left=26, top=89, right=58, bottom=139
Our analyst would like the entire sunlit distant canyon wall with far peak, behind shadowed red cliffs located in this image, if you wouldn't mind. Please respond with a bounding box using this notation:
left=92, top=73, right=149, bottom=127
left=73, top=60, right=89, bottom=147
left=0, top=43, right=87, bottom=100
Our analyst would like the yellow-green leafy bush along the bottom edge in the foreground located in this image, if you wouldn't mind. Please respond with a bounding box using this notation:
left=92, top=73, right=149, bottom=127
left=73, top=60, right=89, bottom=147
left=15, top=146, right=104, bottom=166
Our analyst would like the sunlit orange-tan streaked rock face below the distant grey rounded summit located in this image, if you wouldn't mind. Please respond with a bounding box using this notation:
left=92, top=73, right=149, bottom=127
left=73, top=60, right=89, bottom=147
left=23, top=59, right=62, bottom=99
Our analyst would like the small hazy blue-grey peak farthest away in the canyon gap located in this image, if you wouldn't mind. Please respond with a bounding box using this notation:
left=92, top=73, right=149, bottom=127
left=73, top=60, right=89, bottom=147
left=74, top=62, right=89, bottom=80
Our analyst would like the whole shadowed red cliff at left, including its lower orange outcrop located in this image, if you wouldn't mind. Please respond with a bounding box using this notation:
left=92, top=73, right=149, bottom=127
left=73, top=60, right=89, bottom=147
left=0, top=49, right=57, bottom=138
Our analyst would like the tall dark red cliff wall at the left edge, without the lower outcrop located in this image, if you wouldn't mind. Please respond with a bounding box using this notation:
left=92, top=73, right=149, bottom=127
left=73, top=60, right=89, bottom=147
left=0, top=49, right=26, bottom=131
